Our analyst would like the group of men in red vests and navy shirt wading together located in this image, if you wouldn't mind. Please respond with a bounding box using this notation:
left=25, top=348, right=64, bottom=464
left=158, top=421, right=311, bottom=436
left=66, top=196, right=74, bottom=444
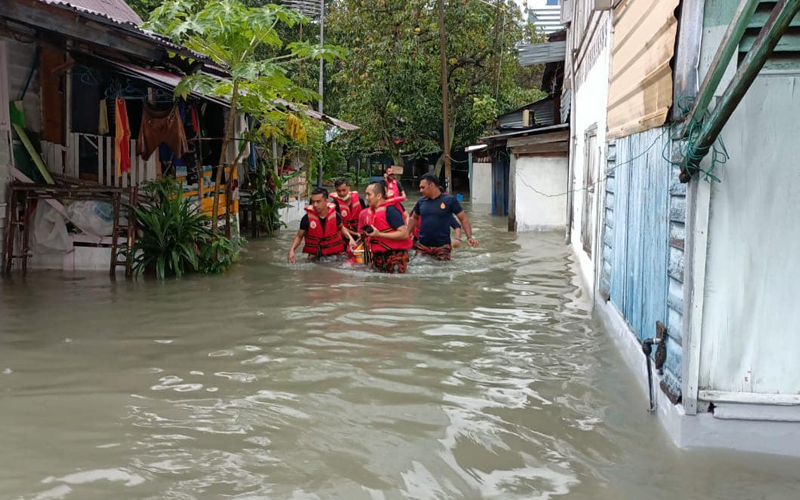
left=288, top=167, right=478, bottom=274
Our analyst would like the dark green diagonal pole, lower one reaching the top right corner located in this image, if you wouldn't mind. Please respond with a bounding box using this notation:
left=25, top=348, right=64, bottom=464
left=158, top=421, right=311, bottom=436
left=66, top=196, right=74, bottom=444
left=690, top=0, right=800, bottom=167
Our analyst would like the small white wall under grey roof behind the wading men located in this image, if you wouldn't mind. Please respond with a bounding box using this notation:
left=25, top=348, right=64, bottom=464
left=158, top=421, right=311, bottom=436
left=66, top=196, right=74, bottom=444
left=514, top=156, right=569, bottom=232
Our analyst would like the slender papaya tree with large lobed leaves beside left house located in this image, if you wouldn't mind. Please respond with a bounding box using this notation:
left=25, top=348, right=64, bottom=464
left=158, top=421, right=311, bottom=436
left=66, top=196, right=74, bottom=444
left=147, top=0, right=340, bottom=230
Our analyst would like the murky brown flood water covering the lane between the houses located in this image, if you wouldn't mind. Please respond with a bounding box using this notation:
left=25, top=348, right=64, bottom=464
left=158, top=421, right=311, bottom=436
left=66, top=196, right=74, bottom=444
left=0, top=201, right=800, bottom=500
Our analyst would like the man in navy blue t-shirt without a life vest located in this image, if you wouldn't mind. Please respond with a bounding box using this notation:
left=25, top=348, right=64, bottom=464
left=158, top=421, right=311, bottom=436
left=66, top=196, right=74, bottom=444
left=408, top=174, right=478, bottom=260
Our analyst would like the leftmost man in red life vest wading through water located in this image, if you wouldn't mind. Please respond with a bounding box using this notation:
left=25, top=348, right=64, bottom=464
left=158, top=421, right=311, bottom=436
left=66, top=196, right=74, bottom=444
left=288, top=188, right=355, bottom=263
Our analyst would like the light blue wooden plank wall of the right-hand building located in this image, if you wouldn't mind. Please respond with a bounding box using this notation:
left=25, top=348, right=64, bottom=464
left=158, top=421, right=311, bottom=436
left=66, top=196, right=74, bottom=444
left=600, top=127, right=686, bottom=402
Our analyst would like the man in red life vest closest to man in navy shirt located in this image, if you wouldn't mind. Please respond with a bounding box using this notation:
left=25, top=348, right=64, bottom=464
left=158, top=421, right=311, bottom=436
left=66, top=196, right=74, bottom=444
left=361, top=182, right=412, bottom=274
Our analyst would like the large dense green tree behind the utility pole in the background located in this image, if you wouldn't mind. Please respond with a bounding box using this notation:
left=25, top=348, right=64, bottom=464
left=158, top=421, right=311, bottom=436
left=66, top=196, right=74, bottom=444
left=326, top=0, right=543, bottom=173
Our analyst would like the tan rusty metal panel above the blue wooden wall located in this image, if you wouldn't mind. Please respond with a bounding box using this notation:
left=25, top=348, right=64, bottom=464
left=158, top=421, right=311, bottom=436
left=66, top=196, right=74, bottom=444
left=608, top=0, right=679, bottom=140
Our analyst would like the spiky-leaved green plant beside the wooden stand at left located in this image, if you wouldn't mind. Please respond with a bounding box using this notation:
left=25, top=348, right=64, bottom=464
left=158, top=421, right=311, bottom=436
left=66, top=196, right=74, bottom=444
left=132, top=177, right=238, bottom=279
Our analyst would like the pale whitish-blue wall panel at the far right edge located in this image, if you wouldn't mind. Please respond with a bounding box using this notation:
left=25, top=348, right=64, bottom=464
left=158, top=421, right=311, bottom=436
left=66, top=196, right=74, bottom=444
left=700, top=75, right=800, bottom=395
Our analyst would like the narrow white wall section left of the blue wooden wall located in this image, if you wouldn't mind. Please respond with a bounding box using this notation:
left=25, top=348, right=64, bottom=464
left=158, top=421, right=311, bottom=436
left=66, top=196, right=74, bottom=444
left=570, top=16, right=611, bottom=289
